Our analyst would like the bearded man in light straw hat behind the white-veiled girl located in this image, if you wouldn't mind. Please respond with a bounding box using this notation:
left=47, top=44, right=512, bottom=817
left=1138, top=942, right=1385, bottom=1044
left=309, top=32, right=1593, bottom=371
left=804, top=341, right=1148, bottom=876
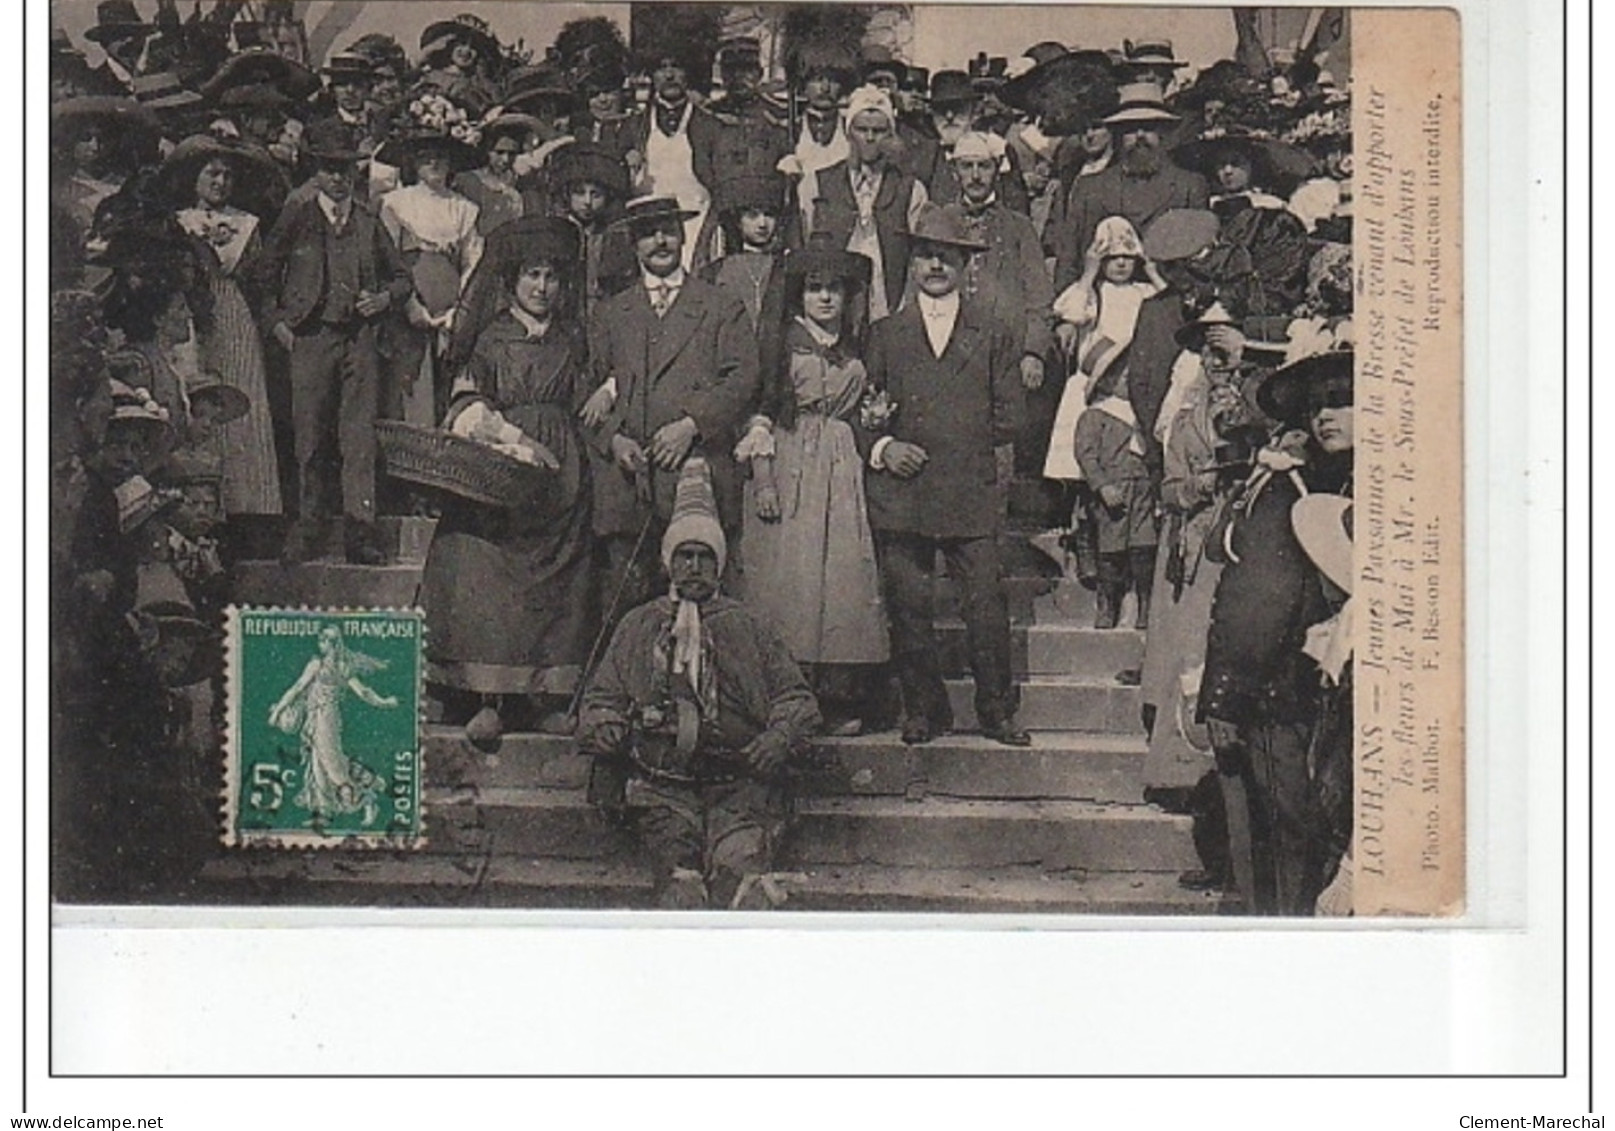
left=1047, top=82, right=1210, bottom=294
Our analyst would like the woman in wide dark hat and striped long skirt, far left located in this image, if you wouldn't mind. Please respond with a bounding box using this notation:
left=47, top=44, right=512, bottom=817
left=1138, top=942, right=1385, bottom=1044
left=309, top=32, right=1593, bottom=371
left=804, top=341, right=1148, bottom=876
left=158, top=136, right=281, bottom=515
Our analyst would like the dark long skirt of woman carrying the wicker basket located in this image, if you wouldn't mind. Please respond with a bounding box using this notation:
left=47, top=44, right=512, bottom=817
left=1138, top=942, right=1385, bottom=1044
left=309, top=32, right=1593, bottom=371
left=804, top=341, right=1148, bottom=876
left=422, top=404, right=594, bottom=695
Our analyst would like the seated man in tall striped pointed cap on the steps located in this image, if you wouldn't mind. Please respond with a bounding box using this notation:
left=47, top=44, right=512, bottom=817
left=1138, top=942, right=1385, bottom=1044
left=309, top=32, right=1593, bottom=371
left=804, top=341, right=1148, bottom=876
left=578, top=459, right=819, bottom=910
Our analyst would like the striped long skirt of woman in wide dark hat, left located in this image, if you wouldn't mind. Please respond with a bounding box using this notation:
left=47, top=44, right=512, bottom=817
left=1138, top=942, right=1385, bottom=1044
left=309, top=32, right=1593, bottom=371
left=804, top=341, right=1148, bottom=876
left=202, top=275, right=281, bottom=514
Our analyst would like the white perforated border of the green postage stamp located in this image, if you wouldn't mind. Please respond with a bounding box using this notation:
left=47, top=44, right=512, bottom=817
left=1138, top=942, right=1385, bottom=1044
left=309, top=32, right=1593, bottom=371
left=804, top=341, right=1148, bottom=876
left=220, top=604, right=426, bottom=851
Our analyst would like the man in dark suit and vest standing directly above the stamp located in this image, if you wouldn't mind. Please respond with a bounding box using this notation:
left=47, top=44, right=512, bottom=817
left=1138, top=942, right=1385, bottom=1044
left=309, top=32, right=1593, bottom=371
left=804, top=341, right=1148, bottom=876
left=255, top=118, right=413, bottom=564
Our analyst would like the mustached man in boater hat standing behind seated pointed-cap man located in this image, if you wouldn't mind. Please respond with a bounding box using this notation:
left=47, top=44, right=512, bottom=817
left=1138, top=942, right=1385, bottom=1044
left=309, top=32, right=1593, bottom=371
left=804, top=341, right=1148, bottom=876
left=585, top=197, right=759, bottom=609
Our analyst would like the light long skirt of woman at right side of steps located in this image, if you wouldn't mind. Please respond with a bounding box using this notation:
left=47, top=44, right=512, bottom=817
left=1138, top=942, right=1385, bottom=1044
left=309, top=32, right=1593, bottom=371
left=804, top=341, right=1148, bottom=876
left=1143, top=526, right=1223, bottom=788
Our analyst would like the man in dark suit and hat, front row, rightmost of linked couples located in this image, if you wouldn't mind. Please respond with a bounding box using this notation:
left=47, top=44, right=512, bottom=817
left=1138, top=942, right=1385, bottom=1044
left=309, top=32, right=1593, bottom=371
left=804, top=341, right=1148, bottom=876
left=854, top=205, right=1032, bottom=746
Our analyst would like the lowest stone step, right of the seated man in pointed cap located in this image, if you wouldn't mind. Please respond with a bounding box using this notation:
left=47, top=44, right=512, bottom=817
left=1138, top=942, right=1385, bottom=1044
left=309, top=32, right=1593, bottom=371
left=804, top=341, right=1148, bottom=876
left=785, top=864, right=1223, bottom=914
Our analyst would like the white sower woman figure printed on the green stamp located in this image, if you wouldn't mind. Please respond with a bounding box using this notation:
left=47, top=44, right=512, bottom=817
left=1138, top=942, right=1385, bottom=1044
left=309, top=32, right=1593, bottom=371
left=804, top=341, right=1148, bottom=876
left=270, top=625, right=399, bottom=824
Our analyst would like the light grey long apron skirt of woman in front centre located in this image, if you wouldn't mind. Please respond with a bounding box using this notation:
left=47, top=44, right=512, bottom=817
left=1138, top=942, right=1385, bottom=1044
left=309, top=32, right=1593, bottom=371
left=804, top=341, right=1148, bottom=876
left=745, top=415, right=891, bottom=664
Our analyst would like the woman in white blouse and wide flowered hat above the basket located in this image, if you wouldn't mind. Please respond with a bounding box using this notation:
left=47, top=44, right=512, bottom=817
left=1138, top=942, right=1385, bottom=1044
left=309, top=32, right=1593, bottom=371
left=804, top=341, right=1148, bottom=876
left=378, top=131, right=483, bottom=425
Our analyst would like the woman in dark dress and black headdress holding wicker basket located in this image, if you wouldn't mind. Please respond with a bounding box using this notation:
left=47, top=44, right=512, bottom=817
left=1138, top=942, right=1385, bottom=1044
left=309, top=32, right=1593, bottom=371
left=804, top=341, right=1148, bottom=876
left=422, top=217, right=593, bottom=742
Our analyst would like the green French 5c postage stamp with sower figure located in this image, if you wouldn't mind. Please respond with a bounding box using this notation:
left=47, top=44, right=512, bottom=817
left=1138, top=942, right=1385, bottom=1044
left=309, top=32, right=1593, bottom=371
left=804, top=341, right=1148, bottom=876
left=224, top=606, right=425, bottom=848
